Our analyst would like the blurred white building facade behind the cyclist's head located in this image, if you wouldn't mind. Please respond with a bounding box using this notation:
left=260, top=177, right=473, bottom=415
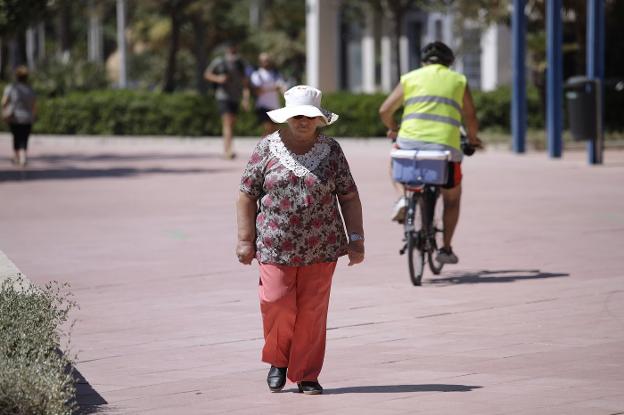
left=306, top=0, right=511, bottom=93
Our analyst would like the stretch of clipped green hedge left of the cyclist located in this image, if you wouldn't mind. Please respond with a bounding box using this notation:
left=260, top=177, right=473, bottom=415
left=29, top=90, right=385, bottom=137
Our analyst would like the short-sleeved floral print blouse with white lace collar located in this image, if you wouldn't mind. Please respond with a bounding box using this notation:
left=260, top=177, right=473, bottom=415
left=240, top=131, right=357, bottom=266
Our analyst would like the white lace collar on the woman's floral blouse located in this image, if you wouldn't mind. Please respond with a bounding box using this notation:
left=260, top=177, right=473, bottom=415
left=269, top=131, right=331, bottom=177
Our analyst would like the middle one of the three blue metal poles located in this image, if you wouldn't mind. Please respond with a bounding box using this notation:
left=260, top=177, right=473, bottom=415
left=546, top=0, right=563, bottom=158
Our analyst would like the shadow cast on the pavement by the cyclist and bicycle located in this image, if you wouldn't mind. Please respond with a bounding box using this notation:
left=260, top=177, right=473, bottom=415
left=426, top=269, right=570, bottom=285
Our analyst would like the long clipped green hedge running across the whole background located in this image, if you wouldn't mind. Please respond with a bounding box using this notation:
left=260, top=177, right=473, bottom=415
left=5, top=87, right=624, bottom=137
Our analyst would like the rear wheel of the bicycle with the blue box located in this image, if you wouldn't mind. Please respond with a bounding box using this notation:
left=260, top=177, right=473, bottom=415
left=404, top=194, right=425, bottom=286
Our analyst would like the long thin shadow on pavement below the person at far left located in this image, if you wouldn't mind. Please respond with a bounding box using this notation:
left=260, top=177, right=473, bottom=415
left=0, top=167, right=230, bottom=182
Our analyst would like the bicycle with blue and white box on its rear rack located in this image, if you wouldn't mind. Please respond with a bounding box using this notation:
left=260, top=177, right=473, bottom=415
left=391, top=137, right=475, bottom=286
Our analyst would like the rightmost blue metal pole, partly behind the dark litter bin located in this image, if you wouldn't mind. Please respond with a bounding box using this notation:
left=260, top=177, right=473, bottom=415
left=587, top=0, right=605, bottom=164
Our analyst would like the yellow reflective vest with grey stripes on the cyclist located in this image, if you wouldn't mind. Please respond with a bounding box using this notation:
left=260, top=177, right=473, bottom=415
left=399, top=64, right=466, bottom=150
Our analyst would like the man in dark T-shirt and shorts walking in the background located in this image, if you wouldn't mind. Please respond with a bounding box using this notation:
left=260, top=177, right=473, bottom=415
left=204, top=43, right=249, bottom=160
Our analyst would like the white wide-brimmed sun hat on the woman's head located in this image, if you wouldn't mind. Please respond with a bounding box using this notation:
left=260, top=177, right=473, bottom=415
left=267, top=85, right=338, bottom=125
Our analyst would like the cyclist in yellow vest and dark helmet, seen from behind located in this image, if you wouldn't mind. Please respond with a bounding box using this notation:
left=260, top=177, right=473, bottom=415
left=379, top=41, right=482, bottom=264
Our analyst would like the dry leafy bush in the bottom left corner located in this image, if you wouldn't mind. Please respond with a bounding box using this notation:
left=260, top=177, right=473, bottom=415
left=0, top=277, right=77, bottom=415
